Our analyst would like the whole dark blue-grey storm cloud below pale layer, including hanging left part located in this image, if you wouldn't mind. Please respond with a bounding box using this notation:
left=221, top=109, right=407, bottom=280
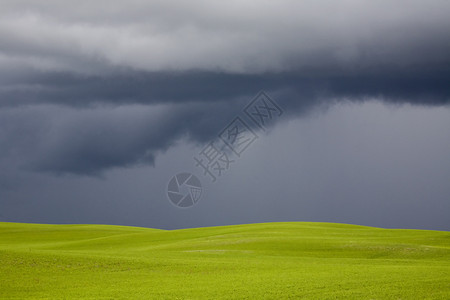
left=0, top=65, right=450, bottom=176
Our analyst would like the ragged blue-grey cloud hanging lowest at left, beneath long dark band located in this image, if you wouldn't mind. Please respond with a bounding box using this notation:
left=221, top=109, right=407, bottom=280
left=0, top=104, right=246, bottom=176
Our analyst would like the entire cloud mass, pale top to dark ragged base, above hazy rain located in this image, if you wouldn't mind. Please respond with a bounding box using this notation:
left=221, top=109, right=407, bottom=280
left=0, top=0, right=450, bottom=175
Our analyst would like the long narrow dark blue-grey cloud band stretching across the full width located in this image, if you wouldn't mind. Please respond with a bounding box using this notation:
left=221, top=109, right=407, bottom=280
left=0, top=62, right=450, bottom=106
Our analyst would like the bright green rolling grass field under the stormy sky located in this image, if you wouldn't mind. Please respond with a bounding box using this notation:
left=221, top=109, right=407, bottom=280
left=0, top=223, right=450, bottom=299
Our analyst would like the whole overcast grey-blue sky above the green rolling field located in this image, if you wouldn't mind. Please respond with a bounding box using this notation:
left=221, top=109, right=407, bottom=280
left=0, top=0, right=450, bottom=230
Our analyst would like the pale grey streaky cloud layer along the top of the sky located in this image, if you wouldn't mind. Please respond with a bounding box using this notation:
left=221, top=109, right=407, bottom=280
left=0, top=0, right=450, bottom=73
